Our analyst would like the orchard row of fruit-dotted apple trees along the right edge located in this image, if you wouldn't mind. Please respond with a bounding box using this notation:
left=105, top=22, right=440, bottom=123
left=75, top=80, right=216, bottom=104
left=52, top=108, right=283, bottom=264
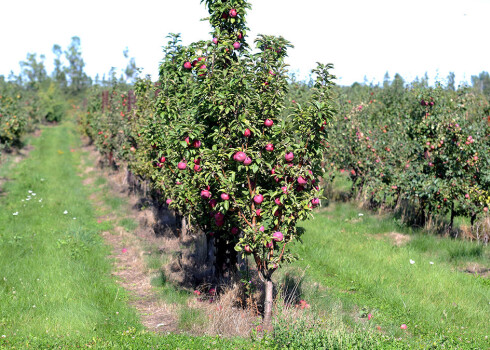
left=325, top=83, right=490, bottom=231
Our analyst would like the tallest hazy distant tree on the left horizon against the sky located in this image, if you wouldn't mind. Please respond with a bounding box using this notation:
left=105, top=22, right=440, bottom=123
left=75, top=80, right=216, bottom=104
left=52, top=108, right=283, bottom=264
left=65, top=36, right=91, bottom=95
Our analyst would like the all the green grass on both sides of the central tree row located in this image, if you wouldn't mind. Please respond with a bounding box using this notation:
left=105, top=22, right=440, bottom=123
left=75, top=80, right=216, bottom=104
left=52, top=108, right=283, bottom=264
left=0, top=118, right=490, bottom=349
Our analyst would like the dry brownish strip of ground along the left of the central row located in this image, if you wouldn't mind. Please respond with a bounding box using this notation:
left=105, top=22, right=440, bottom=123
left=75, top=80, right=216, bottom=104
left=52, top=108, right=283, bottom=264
left=79, top=141, right=178, bottom=333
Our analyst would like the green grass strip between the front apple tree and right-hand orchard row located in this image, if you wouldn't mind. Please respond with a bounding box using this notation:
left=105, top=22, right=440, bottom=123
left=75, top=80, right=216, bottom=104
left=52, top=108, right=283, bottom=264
left=282, top=204, right=490, bottom=348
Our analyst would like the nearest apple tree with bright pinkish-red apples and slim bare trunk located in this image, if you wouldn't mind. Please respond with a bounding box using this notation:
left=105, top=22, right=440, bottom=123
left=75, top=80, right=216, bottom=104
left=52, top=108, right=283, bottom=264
left=146, top=0, right=334, bottom=325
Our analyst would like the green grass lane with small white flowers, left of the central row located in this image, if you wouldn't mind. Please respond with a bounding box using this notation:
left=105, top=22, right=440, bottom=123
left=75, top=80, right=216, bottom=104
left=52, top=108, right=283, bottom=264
left=0, top=122, right=255, bottom=349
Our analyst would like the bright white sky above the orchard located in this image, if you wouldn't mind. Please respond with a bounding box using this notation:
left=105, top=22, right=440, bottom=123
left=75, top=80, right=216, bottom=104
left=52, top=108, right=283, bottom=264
left=0, top=0, right=490, bottom=85
